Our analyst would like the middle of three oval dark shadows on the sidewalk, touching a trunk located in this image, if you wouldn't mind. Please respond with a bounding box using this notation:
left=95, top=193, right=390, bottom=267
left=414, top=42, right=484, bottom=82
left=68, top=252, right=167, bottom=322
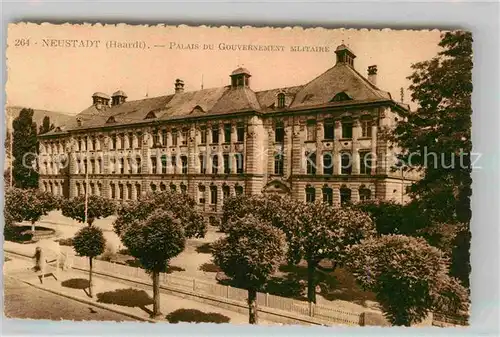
left=97, top=288, right=153, bottom=314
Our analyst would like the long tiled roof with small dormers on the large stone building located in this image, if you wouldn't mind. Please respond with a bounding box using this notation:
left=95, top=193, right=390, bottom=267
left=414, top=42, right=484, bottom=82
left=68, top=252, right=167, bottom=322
left=42, top=63, right=407, bottom=135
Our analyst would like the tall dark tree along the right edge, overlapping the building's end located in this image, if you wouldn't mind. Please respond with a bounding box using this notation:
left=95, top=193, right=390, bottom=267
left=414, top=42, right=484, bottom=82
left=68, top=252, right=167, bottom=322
left=389, top=31, right=473, bottom=285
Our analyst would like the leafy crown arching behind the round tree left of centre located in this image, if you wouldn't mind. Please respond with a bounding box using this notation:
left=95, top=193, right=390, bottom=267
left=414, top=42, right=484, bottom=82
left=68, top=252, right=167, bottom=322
left=113, top=191, right=207, bottom=238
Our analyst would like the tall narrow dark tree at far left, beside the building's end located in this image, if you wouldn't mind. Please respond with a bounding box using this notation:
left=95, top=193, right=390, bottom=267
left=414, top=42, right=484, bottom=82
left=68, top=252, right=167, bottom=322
left=12, top=109, right=38, bottom=188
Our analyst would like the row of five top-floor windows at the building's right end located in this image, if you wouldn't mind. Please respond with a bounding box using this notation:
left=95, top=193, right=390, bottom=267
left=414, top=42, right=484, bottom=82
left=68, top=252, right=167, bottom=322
left=274, top=119, right=373, bottom=143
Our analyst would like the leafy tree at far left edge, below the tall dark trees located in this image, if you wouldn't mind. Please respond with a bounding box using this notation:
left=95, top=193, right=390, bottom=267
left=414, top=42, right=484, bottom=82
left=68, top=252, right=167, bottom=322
left=5, top=188, right=59, bottom=231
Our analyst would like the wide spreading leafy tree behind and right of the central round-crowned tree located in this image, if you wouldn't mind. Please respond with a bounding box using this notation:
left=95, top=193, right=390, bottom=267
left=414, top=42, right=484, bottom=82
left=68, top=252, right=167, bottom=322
left=223, top=196, right=376, bottom=303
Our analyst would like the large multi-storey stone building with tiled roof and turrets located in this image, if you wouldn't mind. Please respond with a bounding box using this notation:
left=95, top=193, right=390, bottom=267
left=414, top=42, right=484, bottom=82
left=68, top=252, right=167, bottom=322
left=39, top=45, right=411, bottom=212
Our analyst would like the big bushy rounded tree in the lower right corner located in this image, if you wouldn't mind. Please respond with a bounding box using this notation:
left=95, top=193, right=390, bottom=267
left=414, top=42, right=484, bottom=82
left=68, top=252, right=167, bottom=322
left=346, top=235, right=468, bottom=326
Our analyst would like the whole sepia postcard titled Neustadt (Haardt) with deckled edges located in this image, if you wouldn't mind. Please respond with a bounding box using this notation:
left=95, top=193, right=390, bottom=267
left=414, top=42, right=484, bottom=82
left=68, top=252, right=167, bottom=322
left=3, top=23, right=474, bottom=327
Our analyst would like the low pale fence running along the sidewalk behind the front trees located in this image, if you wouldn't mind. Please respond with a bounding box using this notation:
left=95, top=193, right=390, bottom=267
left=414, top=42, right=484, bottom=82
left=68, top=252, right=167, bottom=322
left=68, top=256, right=361, bottom=325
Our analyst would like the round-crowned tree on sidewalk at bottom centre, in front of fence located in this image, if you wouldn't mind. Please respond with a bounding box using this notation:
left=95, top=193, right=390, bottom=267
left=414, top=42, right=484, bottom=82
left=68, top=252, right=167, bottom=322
left=213, top=215, right=286, bottom=324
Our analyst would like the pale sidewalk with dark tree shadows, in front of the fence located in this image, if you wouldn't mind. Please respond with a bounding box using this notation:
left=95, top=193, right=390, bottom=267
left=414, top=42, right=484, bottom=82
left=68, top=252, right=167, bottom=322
left=4, top=259, right=276, bottom=325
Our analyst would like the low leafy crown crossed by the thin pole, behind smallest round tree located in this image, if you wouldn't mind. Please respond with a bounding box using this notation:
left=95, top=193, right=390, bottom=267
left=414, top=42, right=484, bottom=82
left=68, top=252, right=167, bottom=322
left=61, top=195, right=116, bottom=226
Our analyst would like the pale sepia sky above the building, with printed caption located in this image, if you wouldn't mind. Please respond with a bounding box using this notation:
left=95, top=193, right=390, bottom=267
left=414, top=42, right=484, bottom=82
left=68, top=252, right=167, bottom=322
left=6, top=24, right=440, bottom=114
